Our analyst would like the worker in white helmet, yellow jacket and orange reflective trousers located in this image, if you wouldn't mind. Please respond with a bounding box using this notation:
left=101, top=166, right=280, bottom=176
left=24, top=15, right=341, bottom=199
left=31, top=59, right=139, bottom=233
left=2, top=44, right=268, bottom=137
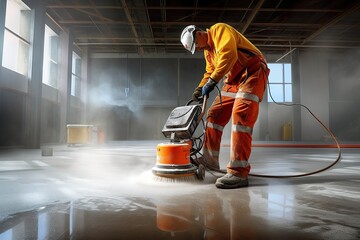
left=180, top=23, right=270, bottom=188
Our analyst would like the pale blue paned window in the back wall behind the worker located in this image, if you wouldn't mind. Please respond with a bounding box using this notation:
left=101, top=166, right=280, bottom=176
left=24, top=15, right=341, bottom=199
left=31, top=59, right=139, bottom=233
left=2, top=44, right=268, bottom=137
left=267, top=63, right=292, bottom=102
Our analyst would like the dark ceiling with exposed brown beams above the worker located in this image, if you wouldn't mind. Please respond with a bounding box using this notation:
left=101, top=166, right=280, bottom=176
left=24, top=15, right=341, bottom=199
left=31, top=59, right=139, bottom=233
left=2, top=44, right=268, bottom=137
left=47, top=0, right=360, bottom=54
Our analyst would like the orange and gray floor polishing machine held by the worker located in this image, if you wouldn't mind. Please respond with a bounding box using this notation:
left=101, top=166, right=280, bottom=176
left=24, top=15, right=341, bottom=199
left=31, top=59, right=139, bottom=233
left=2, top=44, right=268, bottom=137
left=152, top=96, right=207, bottom=180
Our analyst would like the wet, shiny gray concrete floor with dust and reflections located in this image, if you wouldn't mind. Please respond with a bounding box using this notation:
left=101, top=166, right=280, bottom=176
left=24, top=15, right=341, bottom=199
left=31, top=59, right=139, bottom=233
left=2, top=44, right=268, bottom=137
left=0, top=141, right=360, bottom=240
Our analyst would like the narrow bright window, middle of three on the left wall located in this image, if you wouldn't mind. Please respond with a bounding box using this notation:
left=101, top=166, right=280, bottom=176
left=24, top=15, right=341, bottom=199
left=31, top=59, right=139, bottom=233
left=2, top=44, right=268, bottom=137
left=43, top=25, right=59, bottom=88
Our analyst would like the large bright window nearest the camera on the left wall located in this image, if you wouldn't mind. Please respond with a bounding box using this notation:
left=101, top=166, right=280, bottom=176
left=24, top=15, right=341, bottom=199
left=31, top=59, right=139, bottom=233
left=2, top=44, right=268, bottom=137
left=2, top=0, right=31, bottom=76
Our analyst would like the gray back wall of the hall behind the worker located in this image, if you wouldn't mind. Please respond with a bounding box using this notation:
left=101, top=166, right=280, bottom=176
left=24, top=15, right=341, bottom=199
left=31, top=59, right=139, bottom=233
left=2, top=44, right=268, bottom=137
left=88, top=49, right=360, bottom=142
